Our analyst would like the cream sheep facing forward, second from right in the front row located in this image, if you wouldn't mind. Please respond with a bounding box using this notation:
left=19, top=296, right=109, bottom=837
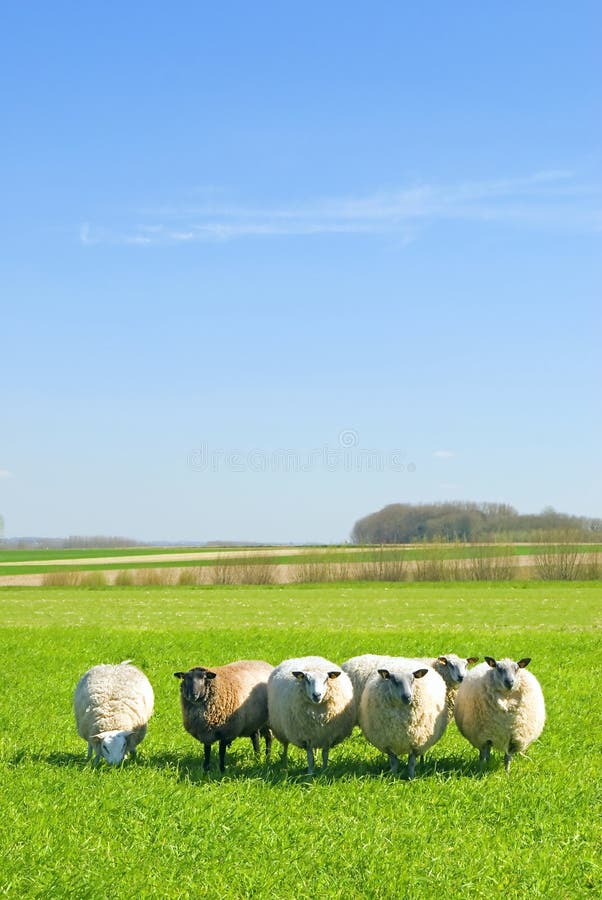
left=358, top=660, right=447, bottom=779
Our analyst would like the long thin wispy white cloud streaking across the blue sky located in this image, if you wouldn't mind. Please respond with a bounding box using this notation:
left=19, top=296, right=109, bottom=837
left=80, top=169, right=602, bottom=246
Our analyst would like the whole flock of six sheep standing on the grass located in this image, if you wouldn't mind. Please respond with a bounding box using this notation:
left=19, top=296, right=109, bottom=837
left=73, top=653, right=546, bottom=779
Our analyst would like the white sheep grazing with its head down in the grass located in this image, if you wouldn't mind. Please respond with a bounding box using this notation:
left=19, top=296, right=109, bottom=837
left=73, top=660, right=155, bottom=765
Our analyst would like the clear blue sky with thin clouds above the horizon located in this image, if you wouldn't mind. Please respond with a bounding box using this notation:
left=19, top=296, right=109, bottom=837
left=0, top=2, right=602, bottom=541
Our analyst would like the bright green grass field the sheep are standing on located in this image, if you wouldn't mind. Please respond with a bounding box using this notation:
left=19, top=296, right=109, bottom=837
left=0, top=582, right=602, bottom=900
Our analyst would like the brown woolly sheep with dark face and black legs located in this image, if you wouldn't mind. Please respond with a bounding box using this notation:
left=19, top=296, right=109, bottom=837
left=174, top=659, right=273, bottom=772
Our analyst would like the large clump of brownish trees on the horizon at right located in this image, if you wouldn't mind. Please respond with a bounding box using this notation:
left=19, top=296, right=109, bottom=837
left=351, top=502, right=602, bottom=544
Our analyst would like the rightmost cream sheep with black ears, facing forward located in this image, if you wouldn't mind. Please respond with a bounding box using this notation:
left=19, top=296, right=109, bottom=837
left=455, top=656, right=546, bottom=772
